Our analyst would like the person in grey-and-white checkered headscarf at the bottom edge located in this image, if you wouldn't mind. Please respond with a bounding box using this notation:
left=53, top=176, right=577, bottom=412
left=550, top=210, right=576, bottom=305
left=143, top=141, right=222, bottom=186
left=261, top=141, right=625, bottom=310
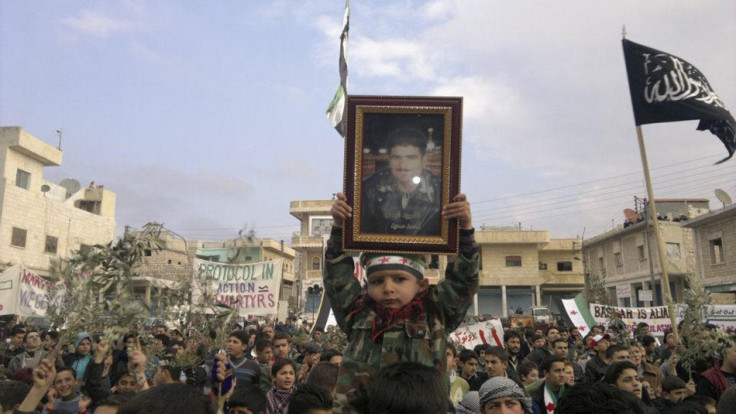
left=478, top=377, right=532, bottom=414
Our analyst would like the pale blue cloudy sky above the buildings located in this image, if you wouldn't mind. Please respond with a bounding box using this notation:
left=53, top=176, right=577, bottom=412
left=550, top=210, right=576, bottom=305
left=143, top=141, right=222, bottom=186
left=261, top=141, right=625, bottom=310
left=0, top=0, right=736, bottom=242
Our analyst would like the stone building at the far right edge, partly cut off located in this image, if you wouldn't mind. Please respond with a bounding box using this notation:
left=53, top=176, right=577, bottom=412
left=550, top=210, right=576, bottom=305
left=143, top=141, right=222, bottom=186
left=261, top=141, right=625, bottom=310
left=683, top=204, right=736, bottom=305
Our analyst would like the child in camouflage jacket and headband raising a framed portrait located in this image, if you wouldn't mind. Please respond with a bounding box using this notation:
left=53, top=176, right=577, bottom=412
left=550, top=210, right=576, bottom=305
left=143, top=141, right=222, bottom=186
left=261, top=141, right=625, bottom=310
left=324, top=193, right=479, bottom=411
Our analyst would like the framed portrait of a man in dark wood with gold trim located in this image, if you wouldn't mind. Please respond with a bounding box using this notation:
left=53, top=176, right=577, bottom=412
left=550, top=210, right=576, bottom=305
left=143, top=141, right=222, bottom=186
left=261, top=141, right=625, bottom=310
left=343, top=96, right=462, bottom=254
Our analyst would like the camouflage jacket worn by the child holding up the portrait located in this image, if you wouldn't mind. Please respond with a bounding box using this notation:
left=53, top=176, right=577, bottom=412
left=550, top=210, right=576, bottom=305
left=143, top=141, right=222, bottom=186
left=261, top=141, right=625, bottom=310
left=324, top=228, right=479, bottom=413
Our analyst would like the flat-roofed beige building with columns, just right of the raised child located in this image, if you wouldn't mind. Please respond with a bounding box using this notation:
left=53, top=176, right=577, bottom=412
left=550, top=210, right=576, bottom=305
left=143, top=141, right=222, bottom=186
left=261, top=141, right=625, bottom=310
left=475, top=227, right=584, bottom=317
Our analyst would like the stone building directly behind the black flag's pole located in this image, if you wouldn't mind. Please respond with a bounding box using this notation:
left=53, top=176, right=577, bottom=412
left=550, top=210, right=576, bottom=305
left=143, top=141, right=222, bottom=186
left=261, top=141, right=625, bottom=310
left=583, top=199, right=709, bottom=307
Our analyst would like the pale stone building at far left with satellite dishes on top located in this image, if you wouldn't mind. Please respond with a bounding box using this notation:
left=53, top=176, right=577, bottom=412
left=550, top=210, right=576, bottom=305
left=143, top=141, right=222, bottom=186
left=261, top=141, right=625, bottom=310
left=0, top=127, right=115, bottom=276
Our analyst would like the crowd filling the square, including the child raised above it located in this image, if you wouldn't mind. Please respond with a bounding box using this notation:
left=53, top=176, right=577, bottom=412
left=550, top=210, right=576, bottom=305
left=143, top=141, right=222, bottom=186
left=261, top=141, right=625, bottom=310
left=0, top=194, right=736, bottom=414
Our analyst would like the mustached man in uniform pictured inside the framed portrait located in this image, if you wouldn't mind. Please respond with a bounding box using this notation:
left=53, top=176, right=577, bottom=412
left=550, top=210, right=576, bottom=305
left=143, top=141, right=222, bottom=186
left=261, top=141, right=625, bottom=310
left=360, top=127, right=442, bottom=236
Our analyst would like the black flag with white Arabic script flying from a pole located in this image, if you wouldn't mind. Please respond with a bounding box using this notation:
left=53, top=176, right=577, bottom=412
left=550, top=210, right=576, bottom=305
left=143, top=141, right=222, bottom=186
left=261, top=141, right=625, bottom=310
left=623, top=39, right=736, bottom=163
